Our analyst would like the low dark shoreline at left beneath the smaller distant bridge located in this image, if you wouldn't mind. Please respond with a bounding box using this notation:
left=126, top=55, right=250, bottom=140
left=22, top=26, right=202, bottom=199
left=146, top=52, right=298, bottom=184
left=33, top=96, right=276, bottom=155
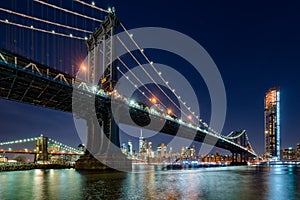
left=0, top=163, right=74, bottom=172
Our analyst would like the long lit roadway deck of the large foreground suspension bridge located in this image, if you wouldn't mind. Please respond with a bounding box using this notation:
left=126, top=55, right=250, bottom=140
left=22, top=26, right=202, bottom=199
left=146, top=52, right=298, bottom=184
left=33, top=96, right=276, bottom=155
left=0, top=50, right=256, bottom=156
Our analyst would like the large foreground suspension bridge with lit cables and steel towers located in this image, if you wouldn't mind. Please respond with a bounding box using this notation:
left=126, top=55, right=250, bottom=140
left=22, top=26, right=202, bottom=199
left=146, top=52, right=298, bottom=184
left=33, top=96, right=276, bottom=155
left=0, top=0, right=257, bottom=169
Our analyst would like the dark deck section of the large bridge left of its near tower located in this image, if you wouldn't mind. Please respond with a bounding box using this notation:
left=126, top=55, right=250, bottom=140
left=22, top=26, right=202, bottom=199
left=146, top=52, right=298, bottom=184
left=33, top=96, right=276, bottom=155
left=0, top=48, right=108, bottom=117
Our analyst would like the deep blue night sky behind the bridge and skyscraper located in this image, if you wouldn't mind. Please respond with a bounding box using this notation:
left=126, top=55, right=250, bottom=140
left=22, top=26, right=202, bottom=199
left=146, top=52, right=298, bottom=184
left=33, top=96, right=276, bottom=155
left=0, top=0, right=300, bottom=153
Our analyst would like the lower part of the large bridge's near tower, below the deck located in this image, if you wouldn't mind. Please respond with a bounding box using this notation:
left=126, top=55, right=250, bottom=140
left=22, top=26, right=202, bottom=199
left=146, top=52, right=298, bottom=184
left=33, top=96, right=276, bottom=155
left=75, top=108, right=132, bottom=171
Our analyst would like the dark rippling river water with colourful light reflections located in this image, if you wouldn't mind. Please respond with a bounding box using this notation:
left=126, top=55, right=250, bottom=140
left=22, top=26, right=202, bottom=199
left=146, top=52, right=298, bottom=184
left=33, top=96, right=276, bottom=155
left=0, top=165, right=300, bottom=200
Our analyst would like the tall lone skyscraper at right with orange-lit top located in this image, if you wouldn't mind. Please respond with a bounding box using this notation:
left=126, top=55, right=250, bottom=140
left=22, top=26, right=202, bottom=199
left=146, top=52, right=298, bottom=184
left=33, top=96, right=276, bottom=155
left=265, top=87, right=281, bottom=159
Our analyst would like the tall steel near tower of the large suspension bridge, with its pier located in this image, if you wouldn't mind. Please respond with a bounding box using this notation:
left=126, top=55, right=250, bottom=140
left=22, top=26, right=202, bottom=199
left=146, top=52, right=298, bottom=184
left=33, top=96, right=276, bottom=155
left=75, top=9, right=131, bottom=170
